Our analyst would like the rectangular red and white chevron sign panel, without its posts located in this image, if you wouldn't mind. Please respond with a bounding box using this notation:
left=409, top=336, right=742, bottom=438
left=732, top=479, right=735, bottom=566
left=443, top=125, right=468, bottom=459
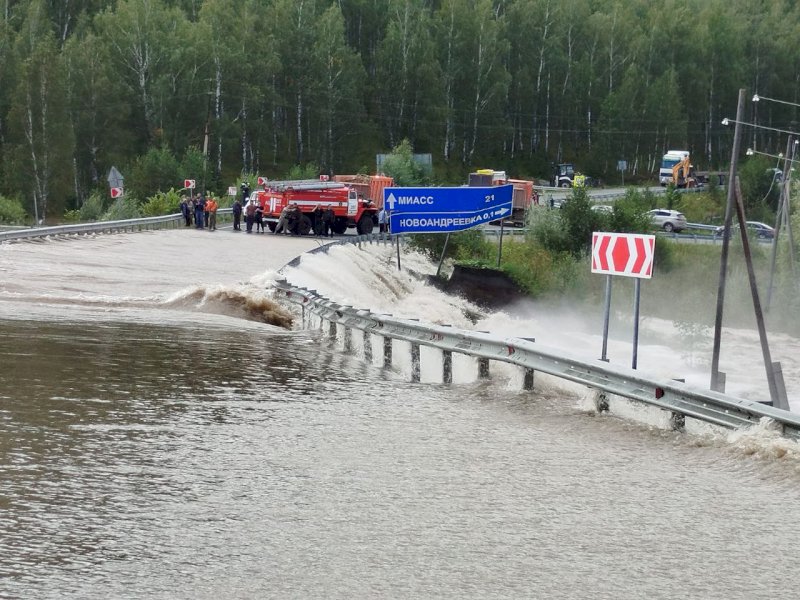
left=592, top=231, right=656, bottom=279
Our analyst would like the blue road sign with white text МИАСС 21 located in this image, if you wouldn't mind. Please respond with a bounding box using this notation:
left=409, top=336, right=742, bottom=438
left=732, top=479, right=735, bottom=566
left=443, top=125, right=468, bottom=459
left=383, top=184, right=514, bottom=233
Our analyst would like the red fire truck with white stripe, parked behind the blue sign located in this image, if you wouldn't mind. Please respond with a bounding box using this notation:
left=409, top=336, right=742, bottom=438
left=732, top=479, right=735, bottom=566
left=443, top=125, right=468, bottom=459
left=251, top=179, right=378, bottom=235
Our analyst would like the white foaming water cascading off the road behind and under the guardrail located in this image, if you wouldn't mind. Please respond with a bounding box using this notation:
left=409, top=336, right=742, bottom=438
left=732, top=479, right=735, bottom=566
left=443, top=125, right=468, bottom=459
left=282, top=240, right=800, bottom=422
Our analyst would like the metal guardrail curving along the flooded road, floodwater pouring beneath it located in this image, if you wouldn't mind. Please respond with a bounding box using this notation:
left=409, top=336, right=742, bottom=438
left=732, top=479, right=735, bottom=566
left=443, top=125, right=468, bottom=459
left=276, top=245, right=800, bottom=440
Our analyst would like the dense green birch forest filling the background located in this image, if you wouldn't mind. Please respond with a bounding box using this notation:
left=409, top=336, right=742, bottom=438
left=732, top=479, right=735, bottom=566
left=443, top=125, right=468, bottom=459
left=0, top=0, right=800, bottom=220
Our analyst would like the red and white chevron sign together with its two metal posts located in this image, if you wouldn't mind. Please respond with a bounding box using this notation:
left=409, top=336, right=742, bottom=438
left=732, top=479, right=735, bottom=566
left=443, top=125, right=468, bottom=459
left=592, top=231, right=656, bottom=369
